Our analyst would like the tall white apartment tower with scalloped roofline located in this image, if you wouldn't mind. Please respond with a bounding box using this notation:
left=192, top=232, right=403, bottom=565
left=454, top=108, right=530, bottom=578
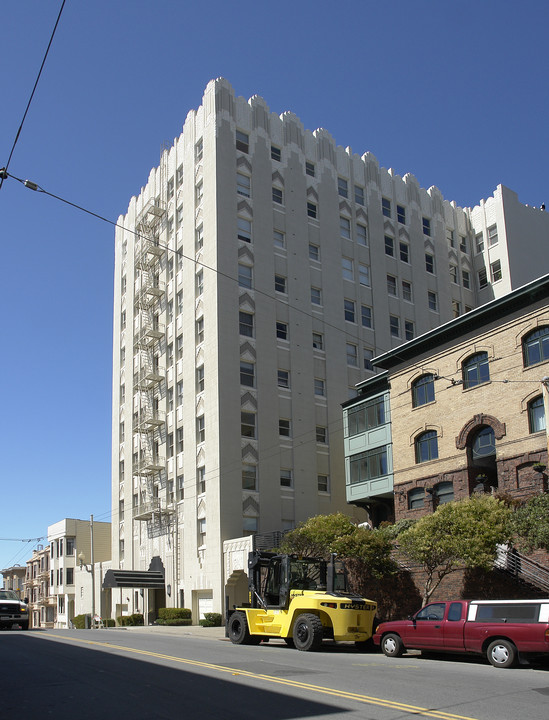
left=112, top=79, right=548, bottom=621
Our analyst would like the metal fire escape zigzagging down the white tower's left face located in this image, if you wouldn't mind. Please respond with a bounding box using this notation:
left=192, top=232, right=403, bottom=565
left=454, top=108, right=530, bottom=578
left=132, top=199, right=171, bottom=534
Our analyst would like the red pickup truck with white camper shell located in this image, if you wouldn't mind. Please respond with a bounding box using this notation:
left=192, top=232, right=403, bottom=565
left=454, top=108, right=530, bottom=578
left=374, top=600, right=549, bottom=668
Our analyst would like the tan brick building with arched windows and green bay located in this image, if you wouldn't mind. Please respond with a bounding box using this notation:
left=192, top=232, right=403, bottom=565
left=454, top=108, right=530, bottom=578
left=343, top=275, right=549, bottom=524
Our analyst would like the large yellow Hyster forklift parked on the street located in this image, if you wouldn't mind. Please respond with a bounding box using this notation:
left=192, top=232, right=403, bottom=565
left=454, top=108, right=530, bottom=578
left=226, top=550, right=377, bottom=651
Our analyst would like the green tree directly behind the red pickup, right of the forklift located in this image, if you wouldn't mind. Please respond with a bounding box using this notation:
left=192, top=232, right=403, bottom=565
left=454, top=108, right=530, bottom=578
left=398, top=495, right=512, bottom=605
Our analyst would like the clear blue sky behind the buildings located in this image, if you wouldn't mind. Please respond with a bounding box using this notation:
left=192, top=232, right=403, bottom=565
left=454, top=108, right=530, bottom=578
left=0, top=0, right=549, bottom=568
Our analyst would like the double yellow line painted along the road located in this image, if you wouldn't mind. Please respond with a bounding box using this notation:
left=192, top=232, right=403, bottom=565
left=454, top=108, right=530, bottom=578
left=39, top=633, right=478, bottom=720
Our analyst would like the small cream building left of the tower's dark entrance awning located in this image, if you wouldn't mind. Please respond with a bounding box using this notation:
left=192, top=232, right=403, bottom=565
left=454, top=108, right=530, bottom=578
left=48, top=518, right=111, bottom=628
